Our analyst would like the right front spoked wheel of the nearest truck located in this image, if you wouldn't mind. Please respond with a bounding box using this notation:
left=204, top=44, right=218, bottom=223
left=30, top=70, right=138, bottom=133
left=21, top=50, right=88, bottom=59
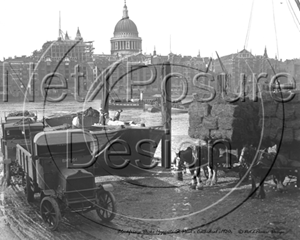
left=96, top=191, right=117, bottom=222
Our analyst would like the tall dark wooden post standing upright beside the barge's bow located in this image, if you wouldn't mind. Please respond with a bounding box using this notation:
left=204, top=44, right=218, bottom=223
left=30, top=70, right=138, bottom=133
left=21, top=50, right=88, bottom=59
left=161, top=62, right=172, bottom=169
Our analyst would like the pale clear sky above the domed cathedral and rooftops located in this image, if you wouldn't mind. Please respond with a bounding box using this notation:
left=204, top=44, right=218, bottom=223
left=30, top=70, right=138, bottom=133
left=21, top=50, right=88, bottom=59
left=0, top=0, right=300, bottom=60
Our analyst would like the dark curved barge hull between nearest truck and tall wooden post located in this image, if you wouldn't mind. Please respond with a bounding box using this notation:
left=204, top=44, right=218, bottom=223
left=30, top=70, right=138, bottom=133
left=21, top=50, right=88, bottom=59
left=91, top=127, right=164, bottom=176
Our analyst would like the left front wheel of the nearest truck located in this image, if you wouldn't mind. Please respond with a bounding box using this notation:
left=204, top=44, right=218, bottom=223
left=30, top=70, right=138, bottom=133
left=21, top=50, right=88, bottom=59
left=40, top=197, right=61, bottom=231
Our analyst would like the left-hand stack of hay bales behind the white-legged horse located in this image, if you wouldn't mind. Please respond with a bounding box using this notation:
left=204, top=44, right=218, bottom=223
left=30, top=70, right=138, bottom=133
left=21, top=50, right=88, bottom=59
left=189, top=94, right=260, bottom=148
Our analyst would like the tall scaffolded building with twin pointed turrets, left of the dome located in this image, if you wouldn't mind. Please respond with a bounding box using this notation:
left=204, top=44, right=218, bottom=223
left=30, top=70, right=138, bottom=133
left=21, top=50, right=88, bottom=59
left=33, top=28, right=94, bottom=93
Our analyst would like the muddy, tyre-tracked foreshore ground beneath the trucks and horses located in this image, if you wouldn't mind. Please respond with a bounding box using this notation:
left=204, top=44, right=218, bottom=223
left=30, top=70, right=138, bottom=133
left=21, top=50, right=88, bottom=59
left=0, top=164, right=300, bottom=240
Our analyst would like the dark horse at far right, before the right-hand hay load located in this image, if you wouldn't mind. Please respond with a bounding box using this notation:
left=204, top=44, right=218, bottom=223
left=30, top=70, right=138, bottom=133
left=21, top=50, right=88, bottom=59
left=240, top=145, right=285, bottom=199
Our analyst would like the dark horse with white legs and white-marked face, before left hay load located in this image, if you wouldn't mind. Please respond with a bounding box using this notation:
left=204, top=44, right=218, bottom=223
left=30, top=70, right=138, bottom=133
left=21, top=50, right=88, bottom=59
left=173, top=144, right=219, bottom=190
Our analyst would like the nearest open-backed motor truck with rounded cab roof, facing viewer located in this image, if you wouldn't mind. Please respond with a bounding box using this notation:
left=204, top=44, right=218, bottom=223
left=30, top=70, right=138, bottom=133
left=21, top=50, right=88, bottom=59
left=16, top=129, right=116, bottom=230
